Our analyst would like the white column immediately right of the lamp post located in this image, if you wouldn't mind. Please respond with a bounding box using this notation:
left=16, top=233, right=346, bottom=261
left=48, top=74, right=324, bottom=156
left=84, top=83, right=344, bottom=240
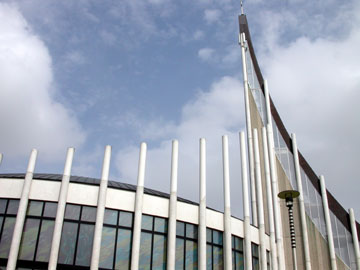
left=291, top=133, right=311, bottom=270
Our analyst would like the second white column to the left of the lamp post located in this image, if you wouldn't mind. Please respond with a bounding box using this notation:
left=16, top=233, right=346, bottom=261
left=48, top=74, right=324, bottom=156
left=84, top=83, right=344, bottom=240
left=261, top=127, right=278, bottom=270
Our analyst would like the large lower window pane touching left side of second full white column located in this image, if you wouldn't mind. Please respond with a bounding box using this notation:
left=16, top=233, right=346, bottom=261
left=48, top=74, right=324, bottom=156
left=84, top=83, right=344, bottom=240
left=36, top=220, right=55, bottom=262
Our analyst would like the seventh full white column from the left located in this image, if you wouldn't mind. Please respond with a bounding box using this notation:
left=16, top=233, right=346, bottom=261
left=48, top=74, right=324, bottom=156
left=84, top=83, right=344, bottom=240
left=222, top=135, right=232, bottom=270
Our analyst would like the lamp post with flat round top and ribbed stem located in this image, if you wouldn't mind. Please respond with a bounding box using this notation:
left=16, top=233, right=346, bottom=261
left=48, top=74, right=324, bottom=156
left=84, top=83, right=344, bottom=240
left=278, top=190, right=300, bottom=270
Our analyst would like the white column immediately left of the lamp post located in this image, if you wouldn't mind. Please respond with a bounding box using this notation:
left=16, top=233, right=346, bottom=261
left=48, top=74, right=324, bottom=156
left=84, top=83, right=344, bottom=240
left=266, top=124, right=285, bottom=270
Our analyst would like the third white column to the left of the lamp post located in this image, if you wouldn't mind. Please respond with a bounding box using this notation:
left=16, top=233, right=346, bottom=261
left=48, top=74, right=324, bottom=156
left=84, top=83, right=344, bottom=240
left=253, top=128, right=267, bottom=270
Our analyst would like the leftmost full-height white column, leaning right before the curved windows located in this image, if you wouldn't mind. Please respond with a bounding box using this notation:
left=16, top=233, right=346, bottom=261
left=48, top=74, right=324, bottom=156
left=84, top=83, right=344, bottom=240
left=6, top=149, right=37, bottom=270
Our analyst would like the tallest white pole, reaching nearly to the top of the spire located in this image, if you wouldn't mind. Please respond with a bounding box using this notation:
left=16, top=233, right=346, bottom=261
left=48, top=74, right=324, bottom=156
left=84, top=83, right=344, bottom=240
left=240, top=33, right=258, bottom=226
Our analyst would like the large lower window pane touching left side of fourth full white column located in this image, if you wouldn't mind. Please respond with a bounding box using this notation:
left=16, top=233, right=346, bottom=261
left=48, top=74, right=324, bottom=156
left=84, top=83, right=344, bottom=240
left=115, top=229, right=132, bottom=270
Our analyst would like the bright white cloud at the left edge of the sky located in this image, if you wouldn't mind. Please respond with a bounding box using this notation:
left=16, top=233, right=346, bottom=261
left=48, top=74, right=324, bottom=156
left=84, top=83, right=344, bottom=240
left=0, top=4, right=85, bottom=161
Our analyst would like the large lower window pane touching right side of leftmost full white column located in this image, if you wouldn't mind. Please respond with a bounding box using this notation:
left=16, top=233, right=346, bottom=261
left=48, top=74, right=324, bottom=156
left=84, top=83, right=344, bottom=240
left=19, top=218, right=40, bottom=261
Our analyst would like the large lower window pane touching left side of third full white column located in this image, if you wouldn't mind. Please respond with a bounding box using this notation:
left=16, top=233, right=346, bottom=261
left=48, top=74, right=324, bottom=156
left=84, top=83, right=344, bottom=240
left=75, top=224, right=95, bottom=266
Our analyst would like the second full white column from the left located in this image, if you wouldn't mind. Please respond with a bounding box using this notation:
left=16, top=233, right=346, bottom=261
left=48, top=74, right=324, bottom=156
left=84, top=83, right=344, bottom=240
left=48, top=148, right=75, bottom=270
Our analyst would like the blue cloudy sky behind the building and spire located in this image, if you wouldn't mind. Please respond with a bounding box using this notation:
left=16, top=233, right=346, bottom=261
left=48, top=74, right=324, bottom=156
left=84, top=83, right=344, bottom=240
left=0, top=0, right=360, bottom=219
